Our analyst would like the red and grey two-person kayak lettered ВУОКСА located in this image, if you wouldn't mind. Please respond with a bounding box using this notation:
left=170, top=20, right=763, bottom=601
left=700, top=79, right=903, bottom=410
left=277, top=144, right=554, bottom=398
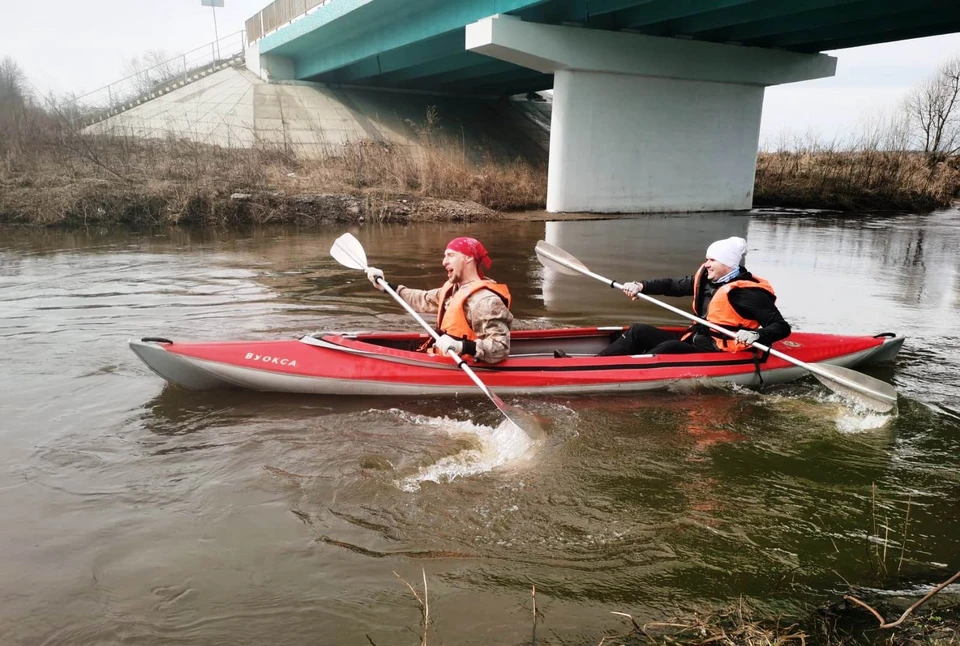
left=130, top=327, right=904, bottom=396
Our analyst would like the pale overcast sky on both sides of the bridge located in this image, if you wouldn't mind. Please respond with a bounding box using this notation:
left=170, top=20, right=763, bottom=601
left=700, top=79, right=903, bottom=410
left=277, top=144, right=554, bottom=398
left=0, top=0, right=960, bottom=146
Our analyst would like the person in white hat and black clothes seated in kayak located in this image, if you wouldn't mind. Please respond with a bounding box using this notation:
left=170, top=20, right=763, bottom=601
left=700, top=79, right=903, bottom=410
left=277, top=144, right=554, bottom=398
left=599, top=237, right=790, bottom=357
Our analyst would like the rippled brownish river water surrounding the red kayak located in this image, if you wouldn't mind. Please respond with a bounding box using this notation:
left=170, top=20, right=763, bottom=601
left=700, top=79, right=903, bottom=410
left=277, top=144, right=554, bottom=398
left=0, top=211, right=960, bottom=645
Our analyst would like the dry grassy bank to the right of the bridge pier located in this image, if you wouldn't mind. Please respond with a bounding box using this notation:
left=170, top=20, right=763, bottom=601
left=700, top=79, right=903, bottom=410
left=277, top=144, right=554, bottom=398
left=753, top=147, right=960, bottom=213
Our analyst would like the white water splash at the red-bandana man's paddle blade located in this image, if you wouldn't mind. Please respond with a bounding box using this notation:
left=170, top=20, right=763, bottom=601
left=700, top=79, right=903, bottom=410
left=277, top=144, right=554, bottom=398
left=394, top=411, right=537, bottom=492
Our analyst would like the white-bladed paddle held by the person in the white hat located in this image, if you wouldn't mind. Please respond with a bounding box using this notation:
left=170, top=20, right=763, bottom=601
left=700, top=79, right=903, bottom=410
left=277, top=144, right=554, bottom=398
left=536, top=240, right=897, bottom=413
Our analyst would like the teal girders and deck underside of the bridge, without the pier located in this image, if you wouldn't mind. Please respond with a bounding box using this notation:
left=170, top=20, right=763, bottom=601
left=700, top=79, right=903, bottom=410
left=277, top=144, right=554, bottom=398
left=259, top=0, right=960, bottom=95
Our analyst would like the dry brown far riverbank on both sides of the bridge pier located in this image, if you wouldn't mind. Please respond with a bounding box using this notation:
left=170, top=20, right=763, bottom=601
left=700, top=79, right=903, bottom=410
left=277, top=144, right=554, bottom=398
left=0, top=131, right=960, bottom=228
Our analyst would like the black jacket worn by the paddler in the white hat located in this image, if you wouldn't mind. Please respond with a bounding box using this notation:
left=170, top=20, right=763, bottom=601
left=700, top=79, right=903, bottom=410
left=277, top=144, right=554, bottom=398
left=640, top=266, right=790, bottom=346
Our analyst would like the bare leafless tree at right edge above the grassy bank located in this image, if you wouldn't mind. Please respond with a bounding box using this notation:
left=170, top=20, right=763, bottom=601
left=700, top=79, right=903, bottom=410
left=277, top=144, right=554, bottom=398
left=906, top=56, right=960, bottom=163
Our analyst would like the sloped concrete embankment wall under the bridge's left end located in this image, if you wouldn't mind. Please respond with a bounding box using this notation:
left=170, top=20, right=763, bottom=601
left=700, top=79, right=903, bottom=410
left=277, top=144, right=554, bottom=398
left=87, top=68, right=551, bottom=163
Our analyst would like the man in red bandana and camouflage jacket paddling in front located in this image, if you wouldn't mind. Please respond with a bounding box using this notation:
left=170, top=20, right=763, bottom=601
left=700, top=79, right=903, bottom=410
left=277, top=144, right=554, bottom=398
left=367, top=237, right=513, bottom=363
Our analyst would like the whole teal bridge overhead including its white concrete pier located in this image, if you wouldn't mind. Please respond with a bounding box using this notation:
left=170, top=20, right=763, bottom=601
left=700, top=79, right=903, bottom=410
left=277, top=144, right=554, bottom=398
left=247, top=0, right=960, bottom=212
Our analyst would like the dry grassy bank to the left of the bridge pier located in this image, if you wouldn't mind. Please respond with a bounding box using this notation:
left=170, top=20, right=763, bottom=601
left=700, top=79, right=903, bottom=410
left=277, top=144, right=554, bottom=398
left=0, top=127, right=546, bottom=226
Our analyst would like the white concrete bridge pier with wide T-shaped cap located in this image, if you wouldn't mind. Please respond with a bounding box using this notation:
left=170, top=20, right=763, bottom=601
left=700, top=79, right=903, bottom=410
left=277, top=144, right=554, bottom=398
left=466, top=15, right=836, bottom=212
